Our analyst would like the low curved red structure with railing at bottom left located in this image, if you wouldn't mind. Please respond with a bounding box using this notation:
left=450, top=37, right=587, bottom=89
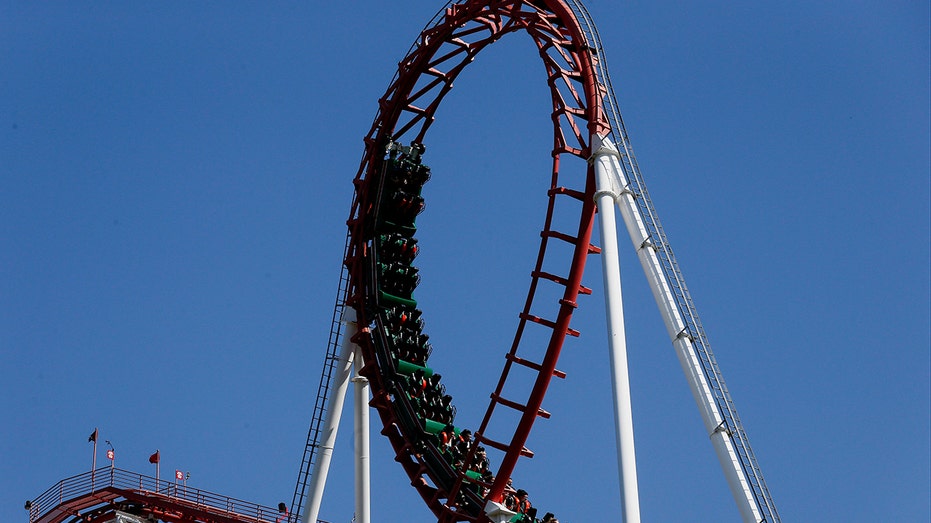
left=26, top=468, right=296, bottom=523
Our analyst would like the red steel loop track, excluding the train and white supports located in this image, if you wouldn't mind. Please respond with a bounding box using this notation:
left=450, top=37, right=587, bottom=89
left=346, top=0, right=610, bottom=521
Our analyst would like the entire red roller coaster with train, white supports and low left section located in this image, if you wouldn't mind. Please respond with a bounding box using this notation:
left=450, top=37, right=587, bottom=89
left=27, top=0, right=780, bottom=523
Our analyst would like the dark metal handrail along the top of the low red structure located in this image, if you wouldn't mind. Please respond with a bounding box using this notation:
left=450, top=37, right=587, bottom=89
left=29, top=468, right=280, bottom=523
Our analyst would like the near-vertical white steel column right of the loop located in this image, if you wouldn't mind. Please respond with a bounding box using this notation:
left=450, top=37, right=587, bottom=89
left=592, top=137, right=640, bottom=523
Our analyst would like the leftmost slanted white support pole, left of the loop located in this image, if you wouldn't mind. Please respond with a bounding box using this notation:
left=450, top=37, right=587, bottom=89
left=301, top=307, right=358, bottom=523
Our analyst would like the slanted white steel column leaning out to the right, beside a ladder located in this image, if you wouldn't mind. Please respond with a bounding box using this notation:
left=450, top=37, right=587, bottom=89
left=592, top=135, right=763, bottom=523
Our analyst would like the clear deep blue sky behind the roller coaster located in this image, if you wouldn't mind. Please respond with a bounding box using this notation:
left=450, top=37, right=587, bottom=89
left=0, top=0, right=931, bottom=523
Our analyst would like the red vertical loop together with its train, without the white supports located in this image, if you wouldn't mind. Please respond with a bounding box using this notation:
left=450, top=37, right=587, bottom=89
left=345, top=0, right=610, bottom=522
